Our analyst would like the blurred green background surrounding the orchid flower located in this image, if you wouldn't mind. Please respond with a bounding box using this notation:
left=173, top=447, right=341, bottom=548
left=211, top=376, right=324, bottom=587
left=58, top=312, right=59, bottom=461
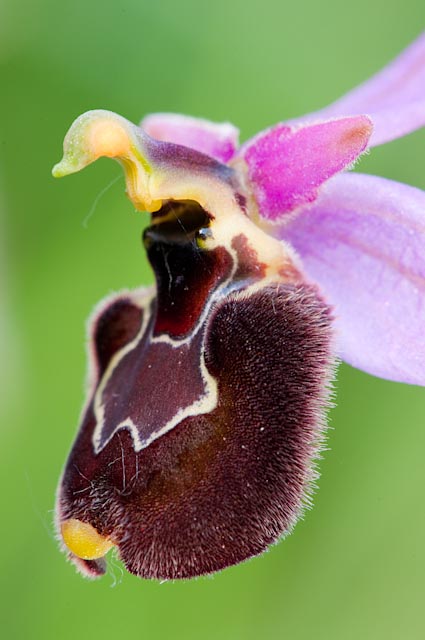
left=0, top=0, right=425, bottom=640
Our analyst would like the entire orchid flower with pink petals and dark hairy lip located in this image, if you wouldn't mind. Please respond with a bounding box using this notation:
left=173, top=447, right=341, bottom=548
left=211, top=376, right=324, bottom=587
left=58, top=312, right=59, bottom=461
left=53, top=36, right=425, bottom=579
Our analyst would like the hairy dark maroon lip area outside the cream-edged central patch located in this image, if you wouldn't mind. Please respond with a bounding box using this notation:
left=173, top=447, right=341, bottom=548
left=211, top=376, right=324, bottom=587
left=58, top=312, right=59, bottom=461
left=60, top=285, right=331, bottom=579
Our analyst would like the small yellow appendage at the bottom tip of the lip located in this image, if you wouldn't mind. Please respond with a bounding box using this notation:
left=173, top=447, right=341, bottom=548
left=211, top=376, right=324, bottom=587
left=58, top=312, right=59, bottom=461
left=61, top=518, right=114, bottom=560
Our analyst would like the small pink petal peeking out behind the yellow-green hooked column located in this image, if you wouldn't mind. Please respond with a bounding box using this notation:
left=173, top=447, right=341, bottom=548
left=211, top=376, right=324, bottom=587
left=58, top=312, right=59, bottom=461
left=140, top=113, right=239, bottom=162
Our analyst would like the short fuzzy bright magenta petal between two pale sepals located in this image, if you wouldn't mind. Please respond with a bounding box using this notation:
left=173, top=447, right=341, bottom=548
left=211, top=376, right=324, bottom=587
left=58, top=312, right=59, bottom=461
left=239, top=116, right=372, bottom=222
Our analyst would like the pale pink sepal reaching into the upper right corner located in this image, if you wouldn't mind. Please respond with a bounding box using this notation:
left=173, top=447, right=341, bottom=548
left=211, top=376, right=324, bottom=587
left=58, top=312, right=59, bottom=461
left=290, top=33, right=425, bottom=147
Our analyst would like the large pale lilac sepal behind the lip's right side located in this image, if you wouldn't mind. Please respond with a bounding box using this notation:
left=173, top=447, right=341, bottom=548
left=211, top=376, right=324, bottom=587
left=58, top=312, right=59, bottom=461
left=281, top=174, right=425, bottom=385
